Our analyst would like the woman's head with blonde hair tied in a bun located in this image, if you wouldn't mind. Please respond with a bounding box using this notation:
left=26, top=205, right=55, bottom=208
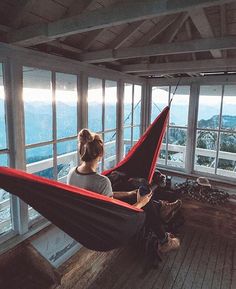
left=79, top=128, right=104, bottom=162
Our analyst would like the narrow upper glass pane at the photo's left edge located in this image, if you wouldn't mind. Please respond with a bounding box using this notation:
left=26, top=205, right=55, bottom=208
left=0, top=63, right=7, bottom=149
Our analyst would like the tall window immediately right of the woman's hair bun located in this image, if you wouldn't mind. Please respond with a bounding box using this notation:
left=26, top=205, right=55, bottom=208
left=88, top=77, right=117, bottom=172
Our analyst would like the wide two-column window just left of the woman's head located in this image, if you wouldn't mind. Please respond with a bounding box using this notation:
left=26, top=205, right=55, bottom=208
left=23, top=67, right=78, bottom=221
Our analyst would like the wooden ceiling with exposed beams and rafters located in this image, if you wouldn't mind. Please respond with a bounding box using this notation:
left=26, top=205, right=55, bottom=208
left=0, top=0, right=236, bottom=77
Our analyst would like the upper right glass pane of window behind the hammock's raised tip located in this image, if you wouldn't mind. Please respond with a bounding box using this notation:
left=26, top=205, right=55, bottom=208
left=170, top=86, right=190, bottom=127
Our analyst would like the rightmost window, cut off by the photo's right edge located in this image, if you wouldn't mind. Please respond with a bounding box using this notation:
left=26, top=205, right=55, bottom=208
left=194, top=85, right=236, bottom=177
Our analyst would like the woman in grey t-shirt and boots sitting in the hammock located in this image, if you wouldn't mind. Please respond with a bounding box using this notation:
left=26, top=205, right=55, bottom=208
left=67, top=129, right=179, bottom=253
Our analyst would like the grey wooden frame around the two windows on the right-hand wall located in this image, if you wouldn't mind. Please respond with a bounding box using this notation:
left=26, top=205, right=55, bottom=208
left=146, top=75, right=236, bottom=182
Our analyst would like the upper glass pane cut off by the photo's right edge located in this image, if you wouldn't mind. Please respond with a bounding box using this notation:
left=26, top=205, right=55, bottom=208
left=221, top=85, right=236, bottom=131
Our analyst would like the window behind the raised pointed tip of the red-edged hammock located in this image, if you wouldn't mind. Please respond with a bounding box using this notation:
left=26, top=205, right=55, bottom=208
left=151, top=86, right=190, bottom=169
